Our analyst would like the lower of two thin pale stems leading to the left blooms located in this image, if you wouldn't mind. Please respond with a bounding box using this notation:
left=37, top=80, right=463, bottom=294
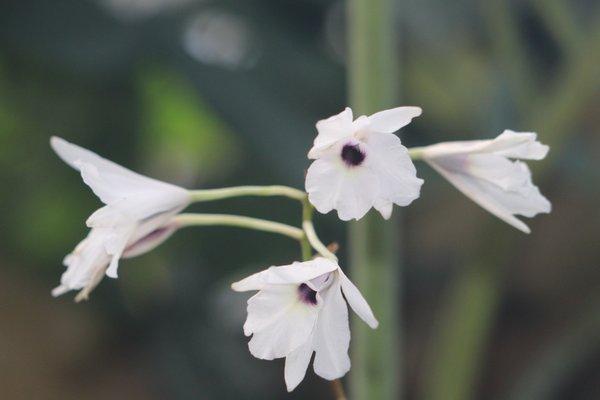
left=173, top=214, right=305, bottom=240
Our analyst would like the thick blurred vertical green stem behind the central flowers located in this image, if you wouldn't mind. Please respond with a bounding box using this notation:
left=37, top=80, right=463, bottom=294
left=347, top=0, right=402, bottom=399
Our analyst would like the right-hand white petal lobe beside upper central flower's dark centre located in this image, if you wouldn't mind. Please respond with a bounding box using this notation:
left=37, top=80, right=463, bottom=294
left=365, top=133, right=423, bottom=209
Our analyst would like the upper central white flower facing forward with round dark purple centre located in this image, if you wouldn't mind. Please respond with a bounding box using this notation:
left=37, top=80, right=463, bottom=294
left=306, top=107, right=423, bottom=221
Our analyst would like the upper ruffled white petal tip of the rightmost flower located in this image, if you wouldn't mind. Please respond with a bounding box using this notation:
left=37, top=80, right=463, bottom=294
left=482, top=129, right=549, bottom=160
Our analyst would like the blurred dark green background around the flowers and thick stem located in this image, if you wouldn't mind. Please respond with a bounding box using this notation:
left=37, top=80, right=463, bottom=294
left=0, top=0, right=600, bottom=400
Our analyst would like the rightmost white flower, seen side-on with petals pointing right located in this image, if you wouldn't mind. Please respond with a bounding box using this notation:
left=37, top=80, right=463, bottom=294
left=422, top=130, right=551, bottom=233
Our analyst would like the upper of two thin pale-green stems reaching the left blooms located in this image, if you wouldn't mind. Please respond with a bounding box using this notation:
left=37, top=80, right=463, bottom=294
left=190, top=185, right=306, bottom=202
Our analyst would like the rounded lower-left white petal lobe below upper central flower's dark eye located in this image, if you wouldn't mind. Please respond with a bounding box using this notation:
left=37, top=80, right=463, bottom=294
left=306, top=155, right=379, bottom=221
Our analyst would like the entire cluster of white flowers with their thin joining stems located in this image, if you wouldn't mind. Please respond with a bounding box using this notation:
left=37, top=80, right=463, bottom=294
left=51, top=107, right=551, bottom=391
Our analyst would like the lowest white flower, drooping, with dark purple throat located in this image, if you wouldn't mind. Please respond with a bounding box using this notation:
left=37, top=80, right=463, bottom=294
left=231, top=257, right=378, bottom=391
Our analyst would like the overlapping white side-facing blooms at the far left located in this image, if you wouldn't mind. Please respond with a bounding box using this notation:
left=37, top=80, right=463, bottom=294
left=50, top=137, right=190, bottom=299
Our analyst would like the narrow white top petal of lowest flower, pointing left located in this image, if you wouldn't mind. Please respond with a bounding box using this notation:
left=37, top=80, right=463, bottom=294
left=231, top=257, right=338, bottom=292
